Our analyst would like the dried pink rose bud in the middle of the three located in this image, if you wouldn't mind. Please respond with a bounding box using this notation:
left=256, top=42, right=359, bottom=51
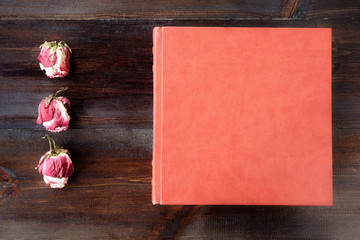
left=36, top=88, right=70, bottom=132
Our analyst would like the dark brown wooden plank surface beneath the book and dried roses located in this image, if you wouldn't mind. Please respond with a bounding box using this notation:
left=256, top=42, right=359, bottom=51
left=0, top=0, right=360, bottom=240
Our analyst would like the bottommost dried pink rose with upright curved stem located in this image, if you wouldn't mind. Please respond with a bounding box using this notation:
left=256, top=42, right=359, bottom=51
left=35, top=135, right=74, bottom=188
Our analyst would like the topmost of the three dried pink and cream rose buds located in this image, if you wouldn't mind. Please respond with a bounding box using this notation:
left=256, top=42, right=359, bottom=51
left=38, top=41, right=71, bottom=78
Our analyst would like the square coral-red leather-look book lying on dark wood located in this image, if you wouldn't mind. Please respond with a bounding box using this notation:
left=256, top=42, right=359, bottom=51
left=152, top=27, right=333, bottom=206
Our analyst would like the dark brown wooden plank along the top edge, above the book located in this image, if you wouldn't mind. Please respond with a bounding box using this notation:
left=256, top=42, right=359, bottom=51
left=0, top=0, right=360, bottom=20
